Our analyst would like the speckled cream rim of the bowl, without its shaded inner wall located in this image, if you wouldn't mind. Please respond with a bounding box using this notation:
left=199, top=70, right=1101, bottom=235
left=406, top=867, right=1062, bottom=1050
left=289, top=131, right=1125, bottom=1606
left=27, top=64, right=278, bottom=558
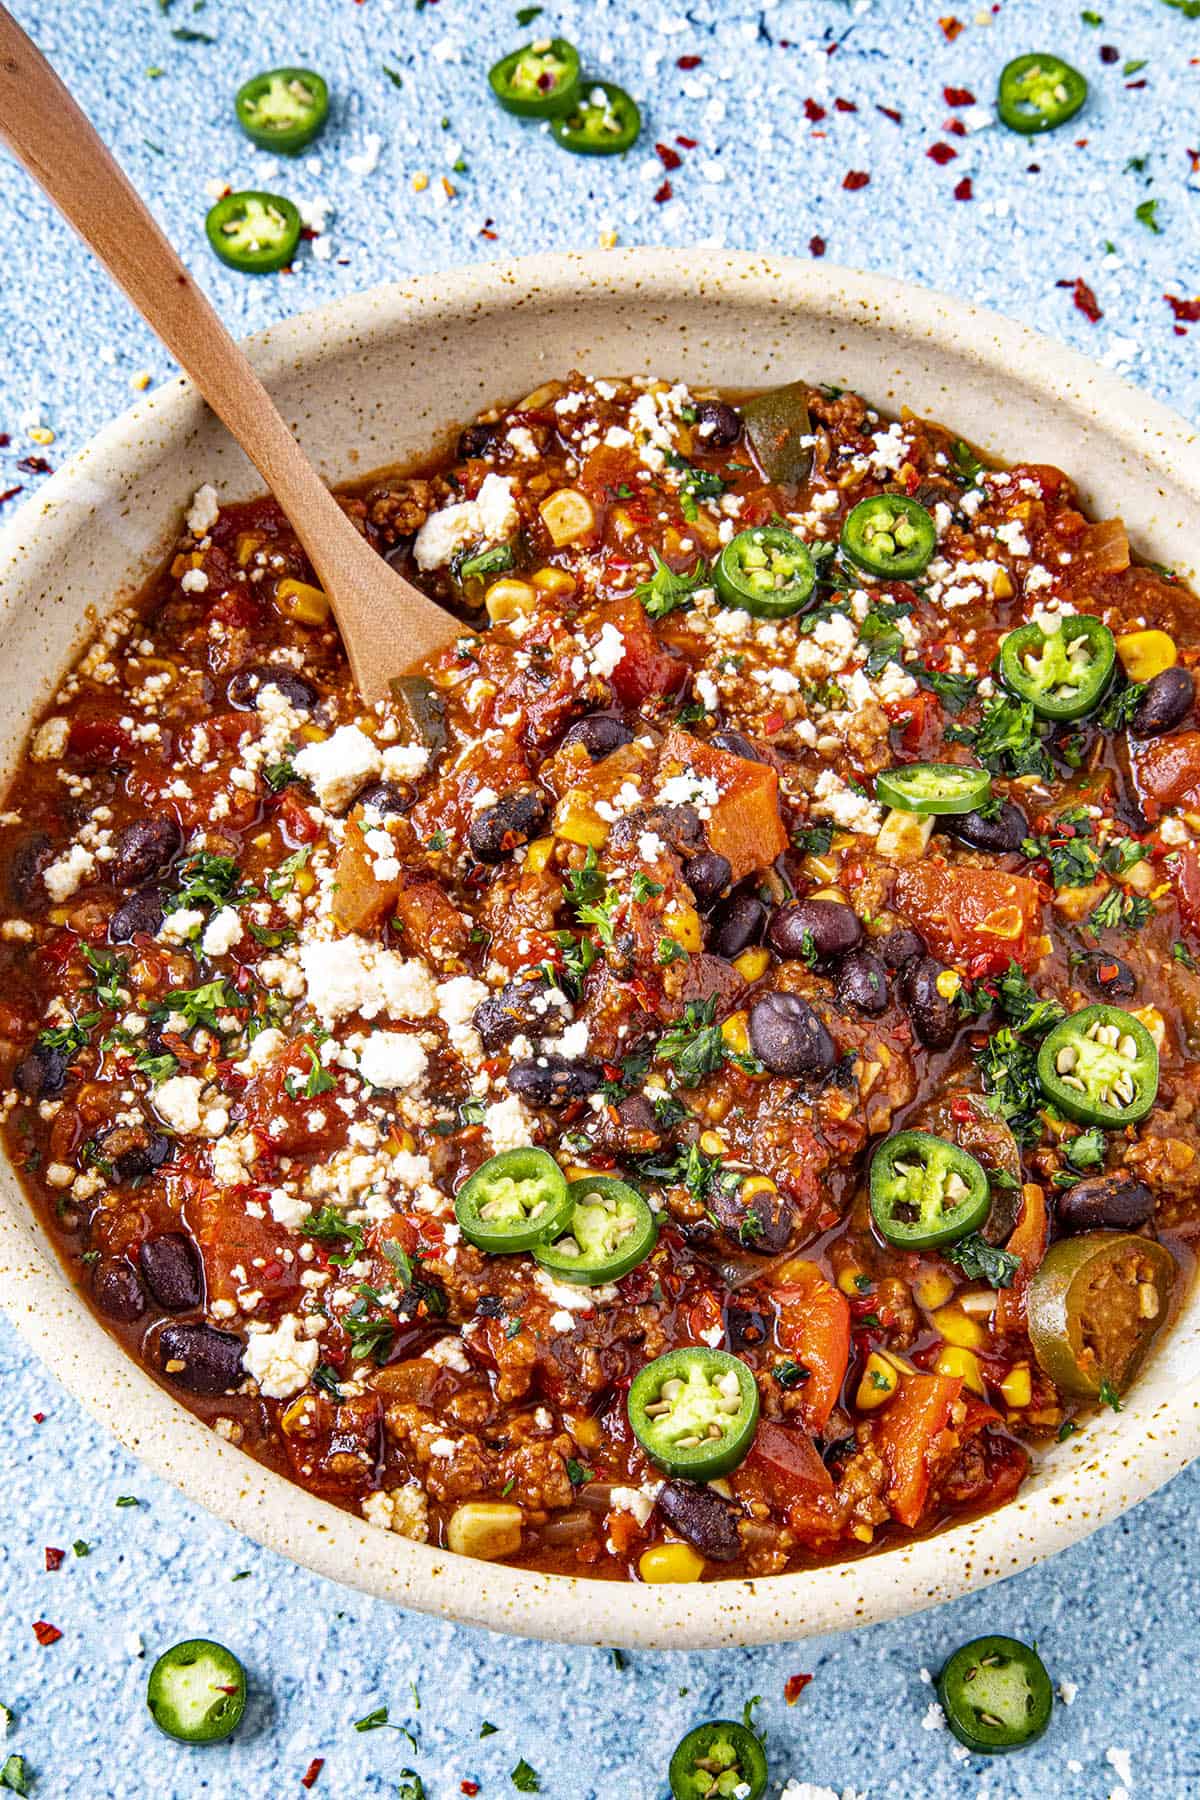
left=0, top=248, right=1200, bottom=1649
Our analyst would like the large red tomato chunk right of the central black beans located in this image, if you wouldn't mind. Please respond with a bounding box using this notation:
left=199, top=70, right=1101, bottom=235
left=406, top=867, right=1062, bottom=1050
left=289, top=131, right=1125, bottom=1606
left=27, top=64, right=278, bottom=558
left=892, top=857, right=1042, bottom=976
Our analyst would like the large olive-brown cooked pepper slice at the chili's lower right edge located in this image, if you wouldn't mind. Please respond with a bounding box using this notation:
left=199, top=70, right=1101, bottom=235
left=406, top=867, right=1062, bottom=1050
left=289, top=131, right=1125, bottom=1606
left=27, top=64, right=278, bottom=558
left=1025, top=1231, right=1178, bottom=1400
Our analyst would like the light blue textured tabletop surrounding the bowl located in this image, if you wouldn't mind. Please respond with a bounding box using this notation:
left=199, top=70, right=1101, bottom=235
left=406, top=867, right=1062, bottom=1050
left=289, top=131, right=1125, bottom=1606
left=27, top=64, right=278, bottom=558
left=0, top=0, right=1200, bottom=1800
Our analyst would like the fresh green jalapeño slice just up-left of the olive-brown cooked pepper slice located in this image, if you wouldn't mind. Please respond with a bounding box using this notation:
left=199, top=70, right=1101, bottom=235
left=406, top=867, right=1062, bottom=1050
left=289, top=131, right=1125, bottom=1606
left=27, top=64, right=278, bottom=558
left=871, top=1130, right=991, bottom=1249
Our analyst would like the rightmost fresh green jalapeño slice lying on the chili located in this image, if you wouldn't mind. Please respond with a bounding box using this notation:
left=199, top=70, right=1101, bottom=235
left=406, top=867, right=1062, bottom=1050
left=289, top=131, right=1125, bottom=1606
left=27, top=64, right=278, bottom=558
left=1038, top=1006, right=1159, bottom=1130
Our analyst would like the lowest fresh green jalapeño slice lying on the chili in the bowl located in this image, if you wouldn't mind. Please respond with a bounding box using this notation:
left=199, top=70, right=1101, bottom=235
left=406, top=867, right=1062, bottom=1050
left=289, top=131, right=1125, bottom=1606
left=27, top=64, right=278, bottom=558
left=628, top=1345, right=759, bottom=1481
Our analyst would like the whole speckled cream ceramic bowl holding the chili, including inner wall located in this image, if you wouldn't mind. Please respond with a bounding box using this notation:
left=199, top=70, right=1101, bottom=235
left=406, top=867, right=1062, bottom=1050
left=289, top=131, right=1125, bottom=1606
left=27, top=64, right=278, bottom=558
left=0, top=250, right=1200, bottom=1649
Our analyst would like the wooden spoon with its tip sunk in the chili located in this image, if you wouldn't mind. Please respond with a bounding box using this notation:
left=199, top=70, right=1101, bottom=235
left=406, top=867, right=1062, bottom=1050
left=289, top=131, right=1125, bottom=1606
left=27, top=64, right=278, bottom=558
left=0, top=5, right=462, bottom=702
